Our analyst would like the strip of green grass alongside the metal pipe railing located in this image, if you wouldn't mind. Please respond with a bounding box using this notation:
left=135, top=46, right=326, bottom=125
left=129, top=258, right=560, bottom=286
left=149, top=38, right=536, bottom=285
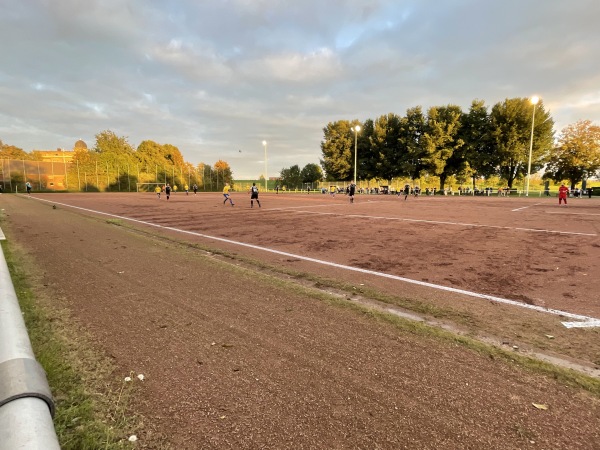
left=2, top=242, right=146, bottom=450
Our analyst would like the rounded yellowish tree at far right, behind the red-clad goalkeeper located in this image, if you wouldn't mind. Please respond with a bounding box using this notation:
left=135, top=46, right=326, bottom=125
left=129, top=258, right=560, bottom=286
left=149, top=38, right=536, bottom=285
left=544, top=120, right=600, bottom=189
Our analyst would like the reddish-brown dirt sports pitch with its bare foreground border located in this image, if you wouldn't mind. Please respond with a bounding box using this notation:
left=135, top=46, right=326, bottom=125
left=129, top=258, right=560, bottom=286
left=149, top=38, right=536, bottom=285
left=0, top=193, right=600, bottom=449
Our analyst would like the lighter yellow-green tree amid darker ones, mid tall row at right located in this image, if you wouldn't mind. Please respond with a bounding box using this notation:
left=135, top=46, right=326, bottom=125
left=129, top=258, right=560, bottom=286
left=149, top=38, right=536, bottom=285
left=423, top=105, right=463, bottom=189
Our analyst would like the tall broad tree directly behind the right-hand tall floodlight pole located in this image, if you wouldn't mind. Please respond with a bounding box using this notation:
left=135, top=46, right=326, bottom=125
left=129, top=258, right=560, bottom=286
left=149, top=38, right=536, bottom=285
left=490, top=98, right=554, bottom=187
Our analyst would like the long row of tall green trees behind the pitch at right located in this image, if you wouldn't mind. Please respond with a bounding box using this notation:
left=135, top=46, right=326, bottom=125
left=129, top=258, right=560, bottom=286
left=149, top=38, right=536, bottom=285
left=314, top=98, right=600, bottom=189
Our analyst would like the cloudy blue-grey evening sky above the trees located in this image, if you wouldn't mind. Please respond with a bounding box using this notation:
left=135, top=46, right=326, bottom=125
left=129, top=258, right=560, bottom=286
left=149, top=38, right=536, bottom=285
left=0, top=0, right=600, bottom=179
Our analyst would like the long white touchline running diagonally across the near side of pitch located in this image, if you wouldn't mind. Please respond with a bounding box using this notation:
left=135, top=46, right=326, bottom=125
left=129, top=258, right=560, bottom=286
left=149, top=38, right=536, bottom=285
left=32, top=197, right=600, bottom=328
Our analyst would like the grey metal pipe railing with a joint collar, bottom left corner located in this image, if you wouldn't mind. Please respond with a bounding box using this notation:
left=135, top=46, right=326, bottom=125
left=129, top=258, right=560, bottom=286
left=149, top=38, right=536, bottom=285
left=0, top=237, right=60, bottom=450
